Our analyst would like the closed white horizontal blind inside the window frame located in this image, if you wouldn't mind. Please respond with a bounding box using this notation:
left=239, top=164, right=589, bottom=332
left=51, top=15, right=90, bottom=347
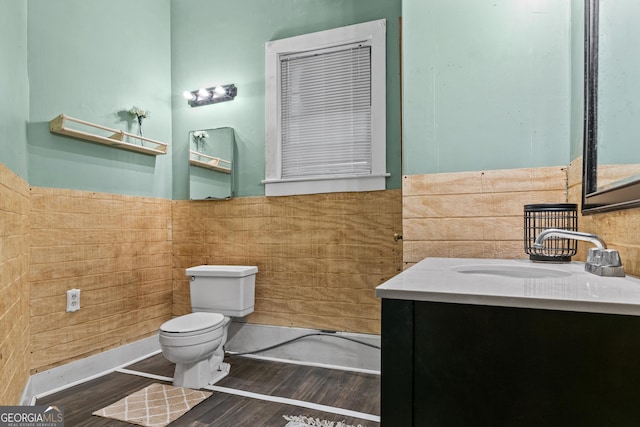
left=280, top=44, right=371, bottom=179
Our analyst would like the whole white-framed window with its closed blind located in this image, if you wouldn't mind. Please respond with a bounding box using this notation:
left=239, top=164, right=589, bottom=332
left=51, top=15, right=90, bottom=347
left=263, top=20, right=388, bottom=196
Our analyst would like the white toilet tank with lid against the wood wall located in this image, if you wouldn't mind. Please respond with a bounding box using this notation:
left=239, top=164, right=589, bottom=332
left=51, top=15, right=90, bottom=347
left=186, top=265, right=258, bottom=317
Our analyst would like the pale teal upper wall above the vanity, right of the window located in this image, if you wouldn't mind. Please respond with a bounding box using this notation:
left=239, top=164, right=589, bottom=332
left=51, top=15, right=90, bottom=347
left=402, top=0, right=571, bottom=174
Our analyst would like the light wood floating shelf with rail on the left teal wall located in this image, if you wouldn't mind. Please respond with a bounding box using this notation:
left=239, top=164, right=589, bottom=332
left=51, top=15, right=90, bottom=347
left=49, top=114, right=167, bottom=156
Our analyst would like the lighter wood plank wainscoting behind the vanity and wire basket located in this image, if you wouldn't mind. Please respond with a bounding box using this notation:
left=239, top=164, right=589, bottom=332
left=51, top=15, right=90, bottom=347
left=402, top=166, right=567, bottom=268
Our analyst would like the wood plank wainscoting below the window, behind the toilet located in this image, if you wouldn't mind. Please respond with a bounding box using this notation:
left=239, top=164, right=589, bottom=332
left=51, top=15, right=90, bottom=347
left=173, top=190, right=402, bottom=334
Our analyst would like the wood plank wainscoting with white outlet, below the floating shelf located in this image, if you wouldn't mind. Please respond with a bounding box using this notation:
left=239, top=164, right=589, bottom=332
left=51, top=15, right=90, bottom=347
left=30, top=188, right=172, bottom=373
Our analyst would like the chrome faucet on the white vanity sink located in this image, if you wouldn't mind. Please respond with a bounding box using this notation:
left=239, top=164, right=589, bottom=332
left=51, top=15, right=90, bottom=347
left=533, top=228, right=624, bottom=277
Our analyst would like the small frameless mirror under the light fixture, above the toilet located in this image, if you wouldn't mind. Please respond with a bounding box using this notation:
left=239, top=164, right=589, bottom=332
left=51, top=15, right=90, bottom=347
left=189, top=127, right=235, bottom=200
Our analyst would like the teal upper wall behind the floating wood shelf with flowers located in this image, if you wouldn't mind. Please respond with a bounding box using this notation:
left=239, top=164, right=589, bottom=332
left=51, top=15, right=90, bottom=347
left=28, top=0, right=172, bottom=198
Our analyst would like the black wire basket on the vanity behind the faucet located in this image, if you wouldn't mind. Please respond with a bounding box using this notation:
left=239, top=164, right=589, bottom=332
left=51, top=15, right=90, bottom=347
left=524, top=203, right=578, bottom=262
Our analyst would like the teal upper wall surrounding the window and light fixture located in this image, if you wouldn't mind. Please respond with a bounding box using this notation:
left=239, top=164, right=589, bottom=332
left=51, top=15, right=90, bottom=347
left=171, top=0, right=401, bottom=199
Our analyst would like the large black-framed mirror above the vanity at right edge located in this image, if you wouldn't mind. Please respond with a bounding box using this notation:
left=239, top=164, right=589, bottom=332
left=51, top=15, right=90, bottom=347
left=582, top=0, right=640, bottom=214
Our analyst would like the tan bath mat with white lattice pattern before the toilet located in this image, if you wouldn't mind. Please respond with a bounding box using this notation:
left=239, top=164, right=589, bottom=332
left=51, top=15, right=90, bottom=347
left=93, top=384, right=211, bottom=427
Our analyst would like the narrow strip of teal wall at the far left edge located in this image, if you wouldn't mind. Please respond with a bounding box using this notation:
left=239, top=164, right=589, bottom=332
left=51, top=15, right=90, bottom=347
left=0, top=0, right=29, bottom=180
